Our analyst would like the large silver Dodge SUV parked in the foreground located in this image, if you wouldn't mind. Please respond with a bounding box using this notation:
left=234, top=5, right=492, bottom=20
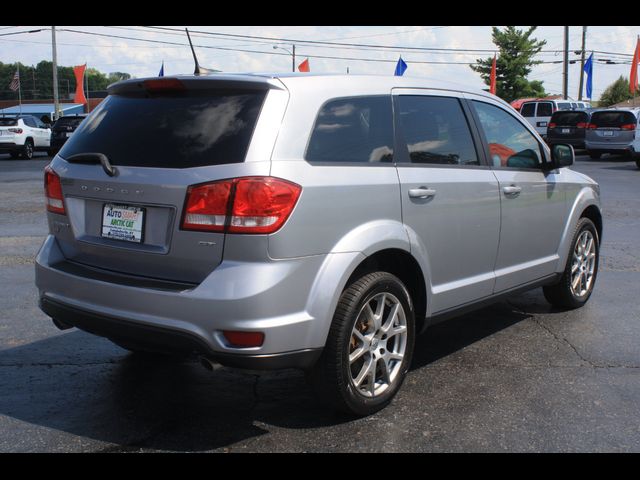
left=36, top=75, right=602, bottom=415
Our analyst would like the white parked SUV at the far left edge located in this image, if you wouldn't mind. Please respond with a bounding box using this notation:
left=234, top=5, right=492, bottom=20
left=0, top=115, right=51, bottom=160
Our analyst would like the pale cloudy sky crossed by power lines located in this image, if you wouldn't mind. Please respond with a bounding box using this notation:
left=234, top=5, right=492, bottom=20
left=0, top=25, right=640, bottom=99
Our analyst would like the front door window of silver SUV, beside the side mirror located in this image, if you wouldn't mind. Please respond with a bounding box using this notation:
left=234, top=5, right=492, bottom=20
left=473, top=101, right=542, bottom=168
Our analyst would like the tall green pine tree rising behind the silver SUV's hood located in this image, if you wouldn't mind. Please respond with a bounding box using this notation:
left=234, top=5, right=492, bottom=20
left=470, top=26, right=547, bottom=102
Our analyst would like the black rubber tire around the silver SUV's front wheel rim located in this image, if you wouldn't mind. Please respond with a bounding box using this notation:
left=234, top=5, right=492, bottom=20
left=542, top=217, right=600, bottom=309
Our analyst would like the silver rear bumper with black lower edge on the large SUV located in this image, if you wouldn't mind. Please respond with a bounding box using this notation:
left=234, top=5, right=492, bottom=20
left=36, top=235, right=331, bottom=369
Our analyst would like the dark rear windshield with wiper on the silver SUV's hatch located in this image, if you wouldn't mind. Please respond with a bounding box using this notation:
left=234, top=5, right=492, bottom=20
left=60, top=90, right=266, bottom=168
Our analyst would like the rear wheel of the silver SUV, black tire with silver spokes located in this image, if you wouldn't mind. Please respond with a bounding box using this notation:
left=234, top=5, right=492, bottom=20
left=308, top=272, right=415, bottom=416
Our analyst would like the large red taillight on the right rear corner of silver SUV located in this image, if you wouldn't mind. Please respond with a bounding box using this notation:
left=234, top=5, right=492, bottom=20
left=182, top=177, right=302, bottom=234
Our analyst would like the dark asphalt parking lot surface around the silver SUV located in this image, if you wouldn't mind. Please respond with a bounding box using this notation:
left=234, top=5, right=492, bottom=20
left=0, top=155, right=640, bottom=452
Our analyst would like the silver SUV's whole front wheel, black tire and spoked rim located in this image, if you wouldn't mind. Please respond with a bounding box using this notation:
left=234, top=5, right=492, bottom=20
left=543, top=217, right=600, bottom=308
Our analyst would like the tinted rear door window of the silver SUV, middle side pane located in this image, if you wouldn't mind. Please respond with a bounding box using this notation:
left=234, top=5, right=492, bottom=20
left=398, top=95, right=480, bottom=165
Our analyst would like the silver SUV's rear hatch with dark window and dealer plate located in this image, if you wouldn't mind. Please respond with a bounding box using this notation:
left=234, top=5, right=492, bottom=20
left=50, top=77, right=268, bottom=283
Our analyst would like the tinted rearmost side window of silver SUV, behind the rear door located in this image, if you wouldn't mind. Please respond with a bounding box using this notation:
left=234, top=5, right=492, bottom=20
left=305, top=96, right=393, bottom=163
